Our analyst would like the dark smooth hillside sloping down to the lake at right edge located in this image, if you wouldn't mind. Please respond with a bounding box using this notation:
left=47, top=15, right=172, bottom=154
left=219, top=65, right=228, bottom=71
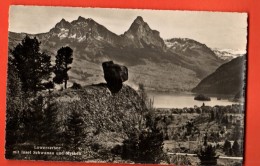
left=192, top=55, right=246, bottom=95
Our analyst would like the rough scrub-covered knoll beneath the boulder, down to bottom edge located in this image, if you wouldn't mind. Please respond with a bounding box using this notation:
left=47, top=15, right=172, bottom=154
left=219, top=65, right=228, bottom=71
left=7, top=84, right=146, bottom=162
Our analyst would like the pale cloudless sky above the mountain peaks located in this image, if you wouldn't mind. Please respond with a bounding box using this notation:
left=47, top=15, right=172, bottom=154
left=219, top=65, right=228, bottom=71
left=9, top=5, right=247, bottom=52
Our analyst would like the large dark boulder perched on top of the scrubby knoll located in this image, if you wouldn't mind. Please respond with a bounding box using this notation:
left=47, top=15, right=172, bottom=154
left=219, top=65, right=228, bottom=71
left=102, top=61, right=128, bottom=93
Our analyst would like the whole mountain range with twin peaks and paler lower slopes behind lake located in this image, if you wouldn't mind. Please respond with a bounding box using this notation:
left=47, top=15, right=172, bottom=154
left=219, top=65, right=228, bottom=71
left=9, top=16, right=232, bottom=92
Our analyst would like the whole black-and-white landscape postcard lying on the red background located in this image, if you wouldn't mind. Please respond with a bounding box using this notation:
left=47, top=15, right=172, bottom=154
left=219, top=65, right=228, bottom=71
left=5, top=5, right=248, bottom=166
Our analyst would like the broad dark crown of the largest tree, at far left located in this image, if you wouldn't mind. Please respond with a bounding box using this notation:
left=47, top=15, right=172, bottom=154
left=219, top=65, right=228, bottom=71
left=10, top=36, right=51, bottom=94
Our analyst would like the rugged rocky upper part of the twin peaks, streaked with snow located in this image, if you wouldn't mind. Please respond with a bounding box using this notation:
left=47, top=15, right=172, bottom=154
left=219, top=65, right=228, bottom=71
left=49, top=16, right=166, bottom=49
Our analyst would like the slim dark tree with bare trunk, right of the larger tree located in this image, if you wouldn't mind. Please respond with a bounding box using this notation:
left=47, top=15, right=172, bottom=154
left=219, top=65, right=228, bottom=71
left=53, top=46, right=73, bottom=89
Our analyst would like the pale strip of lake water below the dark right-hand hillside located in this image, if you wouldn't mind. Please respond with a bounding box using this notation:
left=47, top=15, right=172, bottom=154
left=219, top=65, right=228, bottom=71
left=147, top=93, right=239, bottom=108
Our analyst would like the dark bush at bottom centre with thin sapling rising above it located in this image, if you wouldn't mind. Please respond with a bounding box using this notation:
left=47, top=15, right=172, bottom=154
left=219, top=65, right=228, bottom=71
left=121, top=85, right=165, bottom=164
